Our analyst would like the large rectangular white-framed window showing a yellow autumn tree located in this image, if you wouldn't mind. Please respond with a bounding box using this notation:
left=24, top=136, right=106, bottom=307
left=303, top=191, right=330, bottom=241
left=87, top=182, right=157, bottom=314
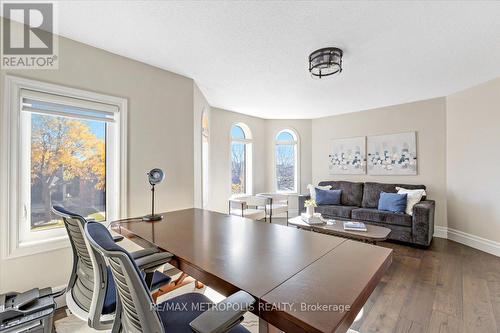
left=4, top=77, right=126, bottom=252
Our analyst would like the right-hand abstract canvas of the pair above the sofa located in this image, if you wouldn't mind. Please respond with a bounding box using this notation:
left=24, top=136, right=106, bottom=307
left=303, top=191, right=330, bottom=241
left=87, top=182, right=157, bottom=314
left=367, top=132, right=417, bottom=175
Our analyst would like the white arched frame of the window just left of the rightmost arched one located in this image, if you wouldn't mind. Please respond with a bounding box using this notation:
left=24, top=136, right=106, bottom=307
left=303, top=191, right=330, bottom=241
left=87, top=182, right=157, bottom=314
left=229, top=122, right=253, bottom=196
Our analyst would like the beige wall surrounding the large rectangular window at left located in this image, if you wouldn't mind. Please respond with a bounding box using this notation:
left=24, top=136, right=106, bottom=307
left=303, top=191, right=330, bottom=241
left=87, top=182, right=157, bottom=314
left=0, top=38, right=194, bottom=292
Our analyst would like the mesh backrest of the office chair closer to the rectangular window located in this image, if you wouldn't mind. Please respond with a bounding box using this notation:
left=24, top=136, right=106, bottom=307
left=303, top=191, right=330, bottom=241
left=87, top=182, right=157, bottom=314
left=52, top=206, right=113, bottom=330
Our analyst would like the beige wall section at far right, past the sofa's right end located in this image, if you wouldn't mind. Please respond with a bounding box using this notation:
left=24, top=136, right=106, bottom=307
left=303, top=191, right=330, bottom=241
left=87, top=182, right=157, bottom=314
left=447, top=78, right=500, bottom=242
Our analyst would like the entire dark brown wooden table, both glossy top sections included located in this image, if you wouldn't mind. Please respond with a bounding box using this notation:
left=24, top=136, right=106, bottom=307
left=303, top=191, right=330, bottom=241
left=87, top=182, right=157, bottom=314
left=112, top=208, right=391, bottom=333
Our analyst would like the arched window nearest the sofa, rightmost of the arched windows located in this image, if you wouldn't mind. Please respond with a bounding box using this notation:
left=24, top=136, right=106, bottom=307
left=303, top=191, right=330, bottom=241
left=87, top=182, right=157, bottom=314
left=275, top=129, right=298, bottom=193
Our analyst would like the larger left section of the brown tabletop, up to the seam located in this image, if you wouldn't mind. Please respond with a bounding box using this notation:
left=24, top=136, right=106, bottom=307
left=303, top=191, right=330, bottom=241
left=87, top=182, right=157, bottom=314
left=114, top=209, right=345, bottom=298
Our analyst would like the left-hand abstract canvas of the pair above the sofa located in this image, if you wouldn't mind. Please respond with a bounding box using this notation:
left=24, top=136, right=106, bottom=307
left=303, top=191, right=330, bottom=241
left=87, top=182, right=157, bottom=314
left=328, top=136, right=366, bottom=175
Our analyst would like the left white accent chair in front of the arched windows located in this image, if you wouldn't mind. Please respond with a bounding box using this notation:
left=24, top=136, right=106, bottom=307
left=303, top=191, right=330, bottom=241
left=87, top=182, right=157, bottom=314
left=229, top=195, right=270, bottom=220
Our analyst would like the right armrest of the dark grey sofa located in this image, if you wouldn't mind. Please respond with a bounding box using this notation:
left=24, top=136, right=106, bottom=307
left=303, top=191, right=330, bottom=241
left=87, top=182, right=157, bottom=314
left=412, top=200, right=436, bottom=246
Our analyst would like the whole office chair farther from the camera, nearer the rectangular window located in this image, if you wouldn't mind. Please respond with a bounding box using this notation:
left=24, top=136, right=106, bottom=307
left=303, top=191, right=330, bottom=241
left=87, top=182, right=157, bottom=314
left=52, top=206, right=172, bottom=330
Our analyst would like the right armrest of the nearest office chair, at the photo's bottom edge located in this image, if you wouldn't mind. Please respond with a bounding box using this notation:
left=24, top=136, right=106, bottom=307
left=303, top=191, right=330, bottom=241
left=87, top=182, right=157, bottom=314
left=189, top=291, right=255, bottom=333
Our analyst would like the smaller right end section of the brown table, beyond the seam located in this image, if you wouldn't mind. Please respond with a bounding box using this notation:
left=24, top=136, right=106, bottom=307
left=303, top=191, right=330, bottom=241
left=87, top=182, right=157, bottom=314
left=260, top=240, right=392, bottom=333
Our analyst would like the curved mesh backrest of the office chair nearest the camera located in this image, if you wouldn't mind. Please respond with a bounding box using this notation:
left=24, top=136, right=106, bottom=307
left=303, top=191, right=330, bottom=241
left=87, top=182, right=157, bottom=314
left=85, top=222, right=164, bottom=333
